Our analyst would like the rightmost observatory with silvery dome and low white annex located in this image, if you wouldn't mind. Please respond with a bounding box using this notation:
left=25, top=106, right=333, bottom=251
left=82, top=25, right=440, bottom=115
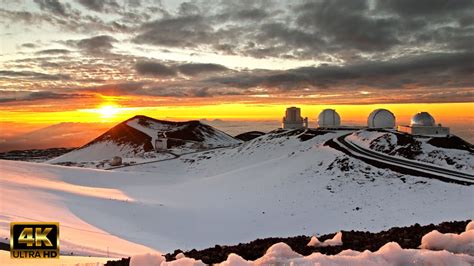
left=397, top=112, right=449, bottom=136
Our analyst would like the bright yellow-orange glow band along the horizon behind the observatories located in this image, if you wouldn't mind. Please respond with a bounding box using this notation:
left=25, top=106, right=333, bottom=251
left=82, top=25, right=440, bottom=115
left=0, top=102, right=474, bottom=124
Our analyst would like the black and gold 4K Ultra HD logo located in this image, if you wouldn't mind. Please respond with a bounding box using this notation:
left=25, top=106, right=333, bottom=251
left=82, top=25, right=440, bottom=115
left=10, top=222, right=59, bottom=259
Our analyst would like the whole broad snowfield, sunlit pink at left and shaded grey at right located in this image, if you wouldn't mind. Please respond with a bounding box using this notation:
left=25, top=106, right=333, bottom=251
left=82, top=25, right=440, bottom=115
left=0, top=131, right=474, bottom=257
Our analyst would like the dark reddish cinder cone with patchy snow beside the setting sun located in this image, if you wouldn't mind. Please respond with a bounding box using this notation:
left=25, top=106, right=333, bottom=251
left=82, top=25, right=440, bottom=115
left=49, top=116, right=240, bottom=167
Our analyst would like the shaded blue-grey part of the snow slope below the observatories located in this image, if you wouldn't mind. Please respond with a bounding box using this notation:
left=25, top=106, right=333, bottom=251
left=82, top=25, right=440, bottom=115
left=44, top=130, right=474, bottom=250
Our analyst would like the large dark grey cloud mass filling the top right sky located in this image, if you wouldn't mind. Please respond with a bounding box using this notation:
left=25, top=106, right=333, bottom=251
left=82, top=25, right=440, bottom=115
left=129, top=0, right=474, bottom=62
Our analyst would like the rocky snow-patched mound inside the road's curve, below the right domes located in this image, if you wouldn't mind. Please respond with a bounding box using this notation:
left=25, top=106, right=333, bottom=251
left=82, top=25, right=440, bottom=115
left=347, top=130, right=474, bottom=172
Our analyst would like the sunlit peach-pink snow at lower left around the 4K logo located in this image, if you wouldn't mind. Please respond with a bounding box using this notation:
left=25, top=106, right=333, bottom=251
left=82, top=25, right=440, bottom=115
left=0, top=161, right=152, bottom=257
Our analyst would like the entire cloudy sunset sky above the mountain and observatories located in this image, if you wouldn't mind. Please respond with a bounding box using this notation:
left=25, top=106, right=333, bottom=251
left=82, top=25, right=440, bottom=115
left=0, top=0, right=474, bottom=149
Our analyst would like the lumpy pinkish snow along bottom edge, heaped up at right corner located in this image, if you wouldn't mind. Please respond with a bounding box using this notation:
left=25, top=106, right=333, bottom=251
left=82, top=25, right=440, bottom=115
left=226, top=222, right=474, bottom=266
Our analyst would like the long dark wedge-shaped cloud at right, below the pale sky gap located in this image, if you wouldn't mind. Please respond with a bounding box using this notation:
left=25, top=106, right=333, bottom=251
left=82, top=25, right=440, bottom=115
left=208, top=53, right=474, bottom=91
